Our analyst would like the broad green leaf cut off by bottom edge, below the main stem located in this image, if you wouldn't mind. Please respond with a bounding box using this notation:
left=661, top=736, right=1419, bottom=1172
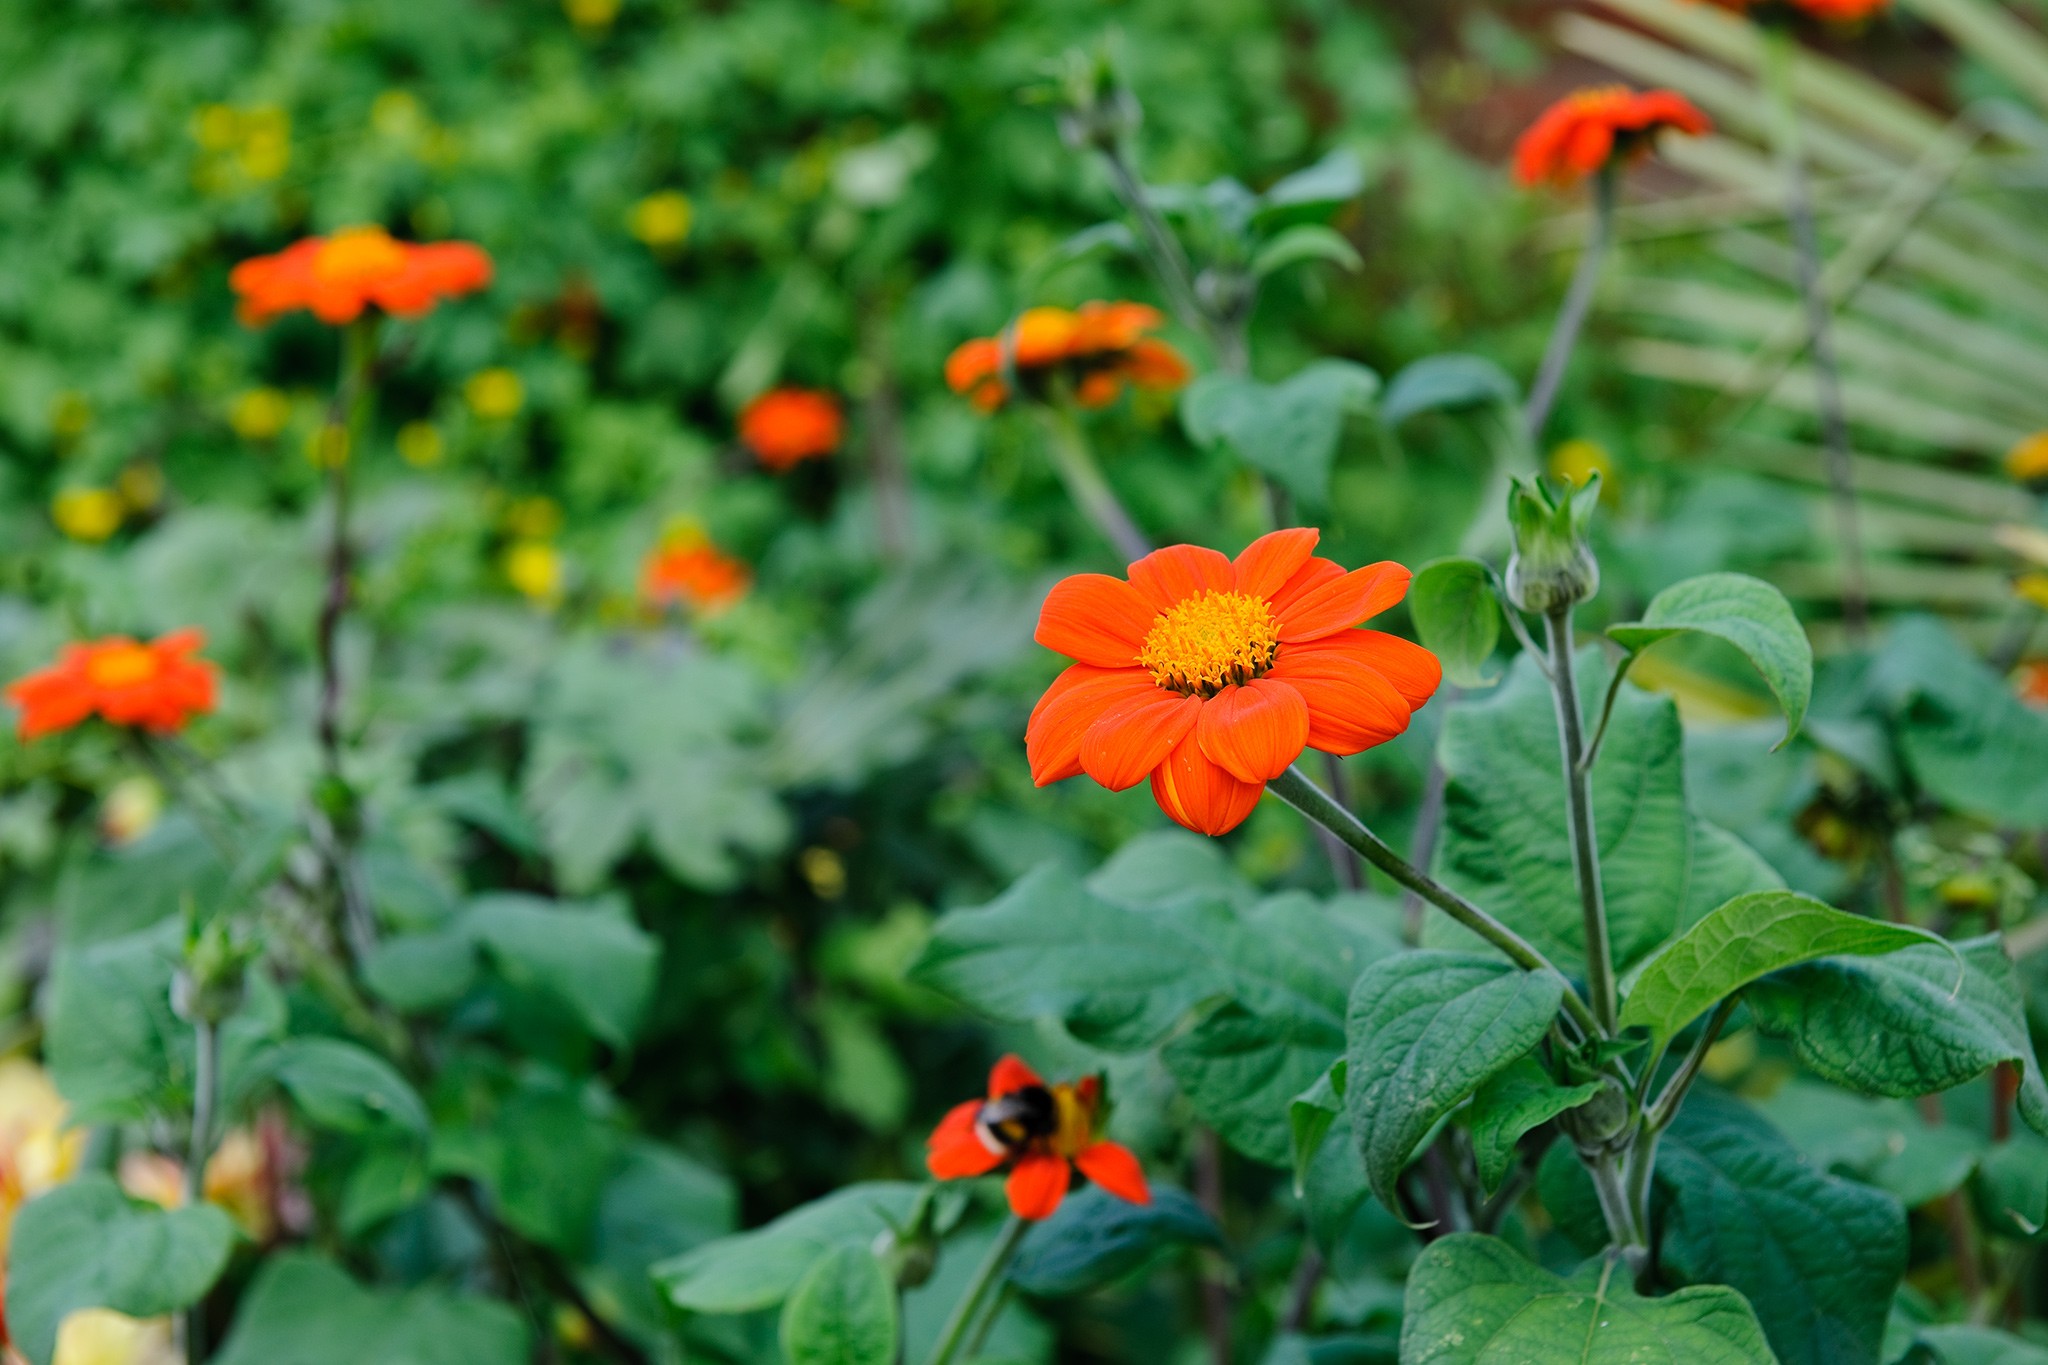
left=1401, top=1232, right=1778, bottom=1365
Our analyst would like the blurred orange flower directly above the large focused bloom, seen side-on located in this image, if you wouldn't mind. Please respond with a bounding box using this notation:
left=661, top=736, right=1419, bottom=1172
left=946, top=303, right=1192, bottom=411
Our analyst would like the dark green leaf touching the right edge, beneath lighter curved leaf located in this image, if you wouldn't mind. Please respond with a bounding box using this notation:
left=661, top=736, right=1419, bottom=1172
left=1747, top=935, right=2048, bottom=1136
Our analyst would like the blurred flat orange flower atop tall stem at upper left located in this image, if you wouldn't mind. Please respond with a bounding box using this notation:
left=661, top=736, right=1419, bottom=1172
left=227, top=227, right=492, bottom=325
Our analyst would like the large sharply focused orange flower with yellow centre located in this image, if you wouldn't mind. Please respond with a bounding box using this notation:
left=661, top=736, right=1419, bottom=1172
left=1024, top=528, right=1442, bottom=835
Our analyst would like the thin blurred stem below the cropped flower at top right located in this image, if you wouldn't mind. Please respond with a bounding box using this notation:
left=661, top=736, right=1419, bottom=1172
left=1763, top=25, right=1870, bottom=645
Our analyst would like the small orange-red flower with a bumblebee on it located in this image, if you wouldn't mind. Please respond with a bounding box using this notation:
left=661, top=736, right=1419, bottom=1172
left=924, top=1056, right=1151, bottom=1220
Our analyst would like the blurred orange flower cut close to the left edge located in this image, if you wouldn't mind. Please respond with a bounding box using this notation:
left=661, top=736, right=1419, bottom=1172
left=6, top=630, right=219, bottom=739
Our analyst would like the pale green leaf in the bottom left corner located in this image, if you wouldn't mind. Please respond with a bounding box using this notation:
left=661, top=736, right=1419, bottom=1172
left=6, top=1175, right=236, bottom=1365
